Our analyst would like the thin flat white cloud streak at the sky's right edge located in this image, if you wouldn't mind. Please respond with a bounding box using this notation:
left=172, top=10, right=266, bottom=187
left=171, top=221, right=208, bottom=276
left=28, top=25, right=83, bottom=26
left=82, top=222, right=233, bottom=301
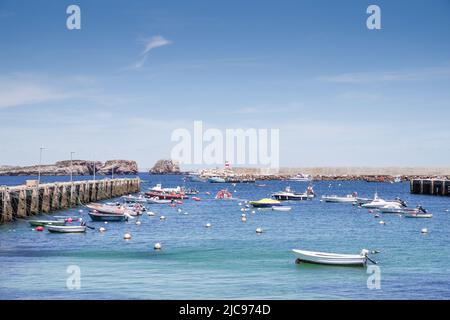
left=318, top=66, right=450, bottom=83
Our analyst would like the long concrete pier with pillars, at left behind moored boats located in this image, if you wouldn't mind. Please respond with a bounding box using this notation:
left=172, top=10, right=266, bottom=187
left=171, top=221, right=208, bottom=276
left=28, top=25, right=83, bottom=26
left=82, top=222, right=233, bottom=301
left=0, top=178, right=141, bottom=223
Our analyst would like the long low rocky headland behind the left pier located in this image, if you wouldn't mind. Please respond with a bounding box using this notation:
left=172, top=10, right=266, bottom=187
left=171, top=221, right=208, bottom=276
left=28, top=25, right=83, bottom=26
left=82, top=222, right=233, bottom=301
left=0, top=160, right=138, bottom=176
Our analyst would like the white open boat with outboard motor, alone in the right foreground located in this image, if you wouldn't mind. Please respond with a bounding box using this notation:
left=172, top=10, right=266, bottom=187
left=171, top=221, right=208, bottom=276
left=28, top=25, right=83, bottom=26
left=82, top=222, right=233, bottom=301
left=292, top=249, right=369, bottom=266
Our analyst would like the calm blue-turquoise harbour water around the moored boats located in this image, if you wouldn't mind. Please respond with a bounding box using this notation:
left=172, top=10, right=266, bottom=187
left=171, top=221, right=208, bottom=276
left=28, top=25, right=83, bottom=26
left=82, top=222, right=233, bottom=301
left=0, top=174, right=450, bottom=299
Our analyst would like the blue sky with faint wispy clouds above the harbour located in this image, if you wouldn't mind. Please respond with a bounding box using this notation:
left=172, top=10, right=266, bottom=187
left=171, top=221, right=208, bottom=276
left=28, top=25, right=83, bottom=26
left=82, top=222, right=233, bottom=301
left=0, top=0, right=450, bottom=169
